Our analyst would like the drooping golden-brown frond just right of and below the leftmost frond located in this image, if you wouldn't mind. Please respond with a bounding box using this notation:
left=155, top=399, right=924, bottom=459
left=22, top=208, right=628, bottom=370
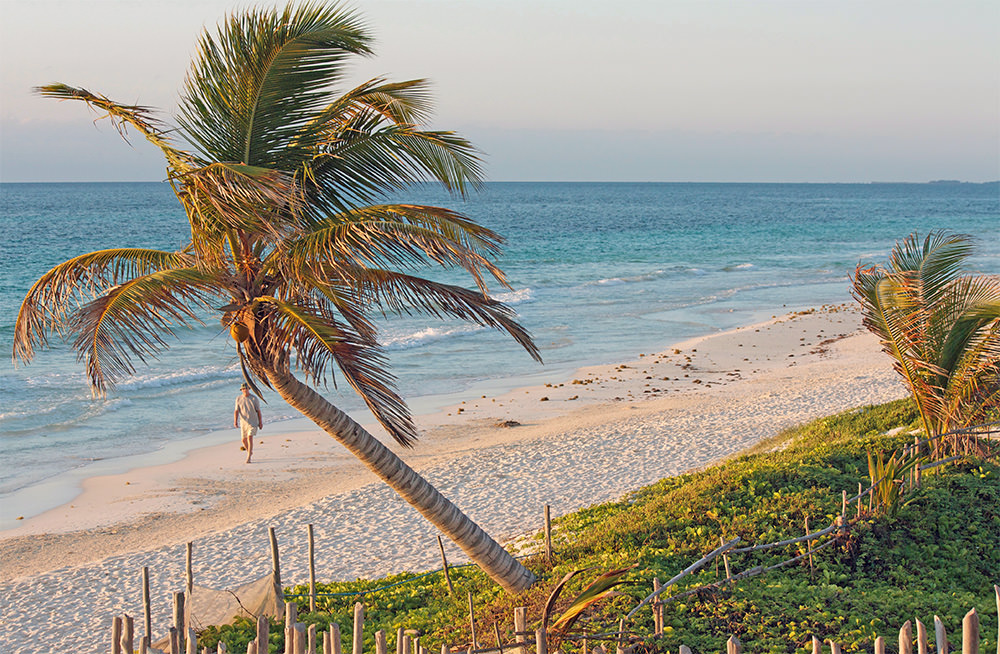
left=69, top=268, right=223, bottom=394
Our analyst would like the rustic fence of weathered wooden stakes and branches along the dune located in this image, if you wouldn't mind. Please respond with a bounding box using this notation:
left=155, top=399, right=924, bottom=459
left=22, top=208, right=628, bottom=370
left=111, top=422, right=1000, bottom=654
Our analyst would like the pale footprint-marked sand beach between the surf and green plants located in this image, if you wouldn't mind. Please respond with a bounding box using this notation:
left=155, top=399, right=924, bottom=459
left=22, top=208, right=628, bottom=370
left=0, top=309, right=905, bottom=653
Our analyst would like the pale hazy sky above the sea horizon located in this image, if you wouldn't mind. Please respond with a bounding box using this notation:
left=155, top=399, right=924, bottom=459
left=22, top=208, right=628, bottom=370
left=0, top=0, right=1000, bottom=182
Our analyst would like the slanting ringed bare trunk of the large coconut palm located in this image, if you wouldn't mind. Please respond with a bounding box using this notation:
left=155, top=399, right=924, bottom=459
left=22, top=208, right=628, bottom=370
left=267, top=369, right=535, bottom=594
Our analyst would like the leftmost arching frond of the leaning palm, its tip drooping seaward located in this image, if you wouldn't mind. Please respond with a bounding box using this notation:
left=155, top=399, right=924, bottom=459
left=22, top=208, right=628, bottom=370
left=14, top=248, right=192, bottom=363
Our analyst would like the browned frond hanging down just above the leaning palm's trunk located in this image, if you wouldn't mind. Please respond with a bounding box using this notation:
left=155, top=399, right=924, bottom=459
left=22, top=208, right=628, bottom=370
left=258, top=298, right=417, bottom=447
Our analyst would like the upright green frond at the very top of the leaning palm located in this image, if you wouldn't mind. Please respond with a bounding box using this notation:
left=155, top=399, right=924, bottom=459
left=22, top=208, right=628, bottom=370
left=179, top=2, right=371, bottom=171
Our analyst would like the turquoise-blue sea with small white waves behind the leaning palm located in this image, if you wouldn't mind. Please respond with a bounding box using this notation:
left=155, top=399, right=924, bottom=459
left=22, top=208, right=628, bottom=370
left=0, top=183, right=1000, bottom=528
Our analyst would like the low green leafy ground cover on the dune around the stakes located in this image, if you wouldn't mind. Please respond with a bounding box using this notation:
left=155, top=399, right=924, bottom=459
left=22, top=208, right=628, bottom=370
left=200, top=400, right=1000, bottom=653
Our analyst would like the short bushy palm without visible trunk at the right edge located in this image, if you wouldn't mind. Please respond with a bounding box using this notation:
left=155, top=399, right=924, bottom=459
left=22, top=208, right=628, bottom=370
left=852, top=232, right=1000, bottom=452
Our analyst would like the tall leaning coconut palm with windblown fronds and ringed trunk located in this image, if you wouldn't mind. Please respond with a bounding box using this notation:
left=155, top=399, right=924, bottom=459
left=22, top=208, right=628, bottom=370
left=14, top=4, right=540, bottom=592
